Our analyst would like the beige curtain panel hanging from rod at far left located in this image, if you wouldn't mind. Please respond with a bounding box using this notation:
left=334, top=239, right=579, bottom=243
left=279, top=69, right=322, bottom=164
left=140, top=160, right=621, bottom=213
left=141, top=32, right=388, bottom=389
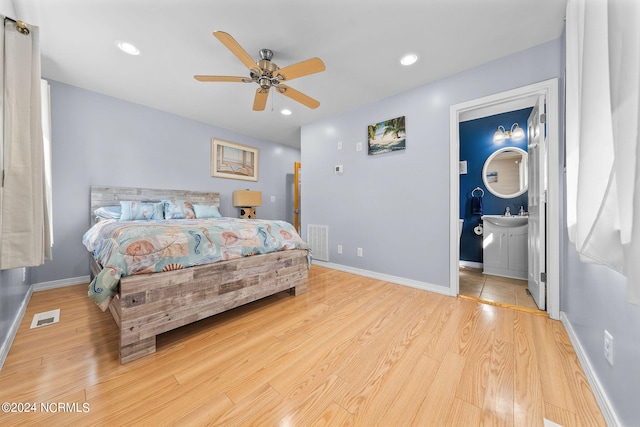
left=0, top=17, right=51, bottom=270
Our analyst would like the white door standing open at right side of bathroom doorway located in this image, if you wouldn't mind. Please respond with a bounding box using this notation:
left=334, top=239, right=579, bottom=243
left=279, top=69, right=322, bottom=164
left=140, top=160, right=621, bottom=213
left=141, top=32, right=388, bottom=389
left=527, top=96, right=547, bottom=310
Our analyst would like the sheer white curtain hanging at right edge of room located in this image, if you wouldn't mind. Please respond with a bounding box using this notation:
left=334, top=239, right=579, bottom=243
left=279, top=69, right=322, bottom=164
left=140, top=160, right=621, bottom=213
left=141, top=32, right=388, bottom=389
left=566, top=0, right=640, bottom=305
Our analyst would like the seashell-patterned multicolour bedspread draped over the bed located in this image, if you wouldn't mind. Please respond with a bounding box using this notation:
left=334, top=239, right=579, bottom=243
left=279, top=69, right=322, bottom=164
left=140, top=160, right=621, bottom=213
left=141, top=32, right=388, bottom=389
left=82, top=218, right=309, bottom=311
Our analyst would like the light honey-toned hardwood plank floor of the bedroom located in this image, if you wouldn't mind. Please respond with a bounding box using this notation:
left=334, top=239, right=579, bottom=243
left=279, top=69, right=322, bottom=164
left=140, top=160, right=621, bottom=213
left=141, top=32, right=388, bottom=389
left=0, top=266, right=605, bottom=426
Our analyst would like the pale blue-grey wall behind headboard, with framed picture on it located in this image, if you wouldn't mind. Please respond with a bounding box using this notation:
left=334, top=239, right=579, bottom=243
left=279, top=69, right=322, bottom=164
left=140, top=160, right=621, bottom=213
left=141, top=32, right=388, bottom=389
left=32, top=81, right=300, bottom=284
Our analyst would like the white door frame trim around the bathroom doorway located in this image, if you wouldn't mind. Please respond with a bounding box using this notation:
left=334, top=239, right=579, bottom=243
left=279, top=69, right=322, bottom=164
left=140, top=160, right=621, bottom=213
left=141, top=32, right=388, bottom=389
left=449, top=78, right=562, bottom=319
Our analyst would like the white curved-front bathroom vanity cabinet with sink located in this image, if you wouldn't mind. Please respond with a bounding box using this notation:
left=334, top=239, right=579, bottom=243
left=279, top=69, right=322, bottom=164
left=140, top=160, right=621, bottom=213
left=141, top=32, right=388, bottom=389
left=482, top=215, right=529, bottom=280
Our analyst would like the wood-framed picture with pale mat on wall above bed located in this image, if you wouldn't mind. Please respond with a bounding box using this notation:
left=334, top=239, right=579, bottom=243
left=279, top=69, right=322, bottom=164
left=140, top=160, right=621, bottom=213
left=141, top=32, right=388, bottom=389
left=211, top=138, right=258, bottom=181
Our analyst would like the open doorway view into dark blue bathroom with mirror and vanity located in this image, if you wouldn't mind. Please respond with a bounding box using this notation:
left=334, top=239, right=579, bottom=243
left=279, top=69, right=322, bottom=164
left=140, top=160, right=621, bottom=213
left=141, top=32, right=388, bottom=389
left=459, top=106, right=544, bottom=313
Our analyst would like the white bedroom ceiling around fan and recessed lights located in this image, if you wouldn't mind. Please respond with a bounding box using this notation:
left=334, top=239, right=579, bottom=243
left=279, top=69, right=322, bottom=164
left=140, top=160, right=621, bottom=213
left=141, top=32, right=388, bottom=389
left=13, top=0, right=566, bottom=147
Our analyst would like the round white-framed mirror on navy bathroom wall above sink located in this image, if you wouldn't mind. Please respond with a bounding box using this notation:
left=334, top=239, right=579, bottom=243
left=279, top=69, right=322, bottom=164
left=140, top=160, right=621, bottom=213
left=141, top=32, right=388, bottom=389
left=482, top=147, right=529, bottom=199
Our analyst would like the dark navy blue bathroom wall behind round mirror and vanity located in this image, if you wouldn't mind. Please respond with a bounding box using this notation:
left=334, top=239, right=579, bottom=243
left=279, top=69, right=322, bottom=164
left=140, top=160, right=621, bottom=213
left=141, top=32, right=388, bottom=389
left=460, top=108, right=532, bottom=263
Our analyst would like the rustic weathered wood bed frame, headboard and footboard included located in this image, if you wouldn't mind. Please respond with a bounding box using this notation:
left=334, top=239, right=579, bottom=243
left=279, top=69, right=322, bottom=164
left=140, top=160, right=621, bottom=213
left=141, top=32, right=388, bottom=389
left=90, top=186, right=309, bottom=364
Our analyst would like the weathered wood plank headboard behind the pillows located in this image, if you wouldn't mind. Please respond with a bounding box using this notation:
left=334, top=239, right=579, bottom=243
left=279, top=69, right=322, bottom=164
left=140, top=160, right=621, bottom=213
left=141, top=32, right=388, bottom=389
left=89, top=185, right=220, bottom=224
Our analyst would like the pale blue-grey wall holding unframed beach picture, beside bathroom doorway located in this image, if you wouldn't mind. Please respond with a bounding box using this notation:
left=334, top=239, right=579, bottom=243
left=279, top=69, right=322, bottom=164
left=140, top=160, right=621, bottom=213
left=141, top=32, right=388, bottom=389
left=301, top=40, right=561, bottom=288
